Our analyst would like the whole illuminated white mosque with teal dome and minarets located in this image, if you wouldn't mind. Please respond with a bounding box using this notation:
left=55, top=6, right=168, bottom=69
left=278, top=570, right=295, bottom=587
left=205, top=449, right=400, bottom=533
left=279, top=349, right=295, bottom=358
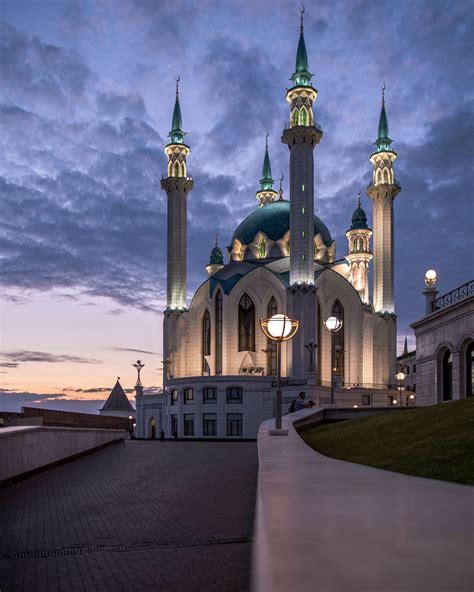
left=136, top=10, right=400, bottom=438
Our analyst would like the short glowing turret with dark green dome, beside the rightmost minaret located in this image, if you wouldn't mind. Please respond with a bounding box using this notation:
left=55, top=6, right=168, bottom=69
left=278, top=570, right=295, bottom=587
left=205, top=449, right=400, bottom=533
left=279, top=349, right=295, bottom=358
left=346, top=191, right=372, bottom=304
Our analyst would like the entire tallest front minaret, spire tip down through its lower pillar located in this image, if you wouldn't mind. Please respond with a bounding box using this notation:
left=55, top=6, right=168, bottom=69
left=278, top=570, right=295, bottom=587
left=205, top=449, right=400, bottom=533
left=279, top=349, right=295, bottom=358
left=281, top=8, right=323, bottom=380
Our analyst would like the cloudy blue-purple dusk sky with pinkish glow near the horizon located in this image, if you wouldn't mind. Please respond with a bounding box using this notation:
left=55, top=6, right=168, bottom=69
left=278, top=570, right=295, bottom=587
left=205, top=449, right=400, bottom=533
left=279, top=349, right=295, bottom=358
left=0, top=0, right=474, bottom=412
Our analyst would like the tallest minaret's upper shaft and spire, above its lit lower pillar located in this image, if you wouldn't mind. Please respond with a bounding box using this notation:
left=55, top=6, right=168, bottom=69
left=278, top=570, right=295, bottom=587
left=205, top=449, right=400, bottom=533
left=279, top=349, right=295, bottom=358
left=281, top=8, right=323, bottom=285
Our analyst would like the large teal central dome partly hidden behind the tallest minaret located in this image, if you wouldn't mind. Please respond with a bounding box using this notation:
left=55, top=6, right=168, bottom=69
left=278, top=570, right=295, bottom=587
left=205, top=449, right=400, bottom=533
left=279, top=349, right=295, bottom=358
left=231, top=199, right=332, bottom=247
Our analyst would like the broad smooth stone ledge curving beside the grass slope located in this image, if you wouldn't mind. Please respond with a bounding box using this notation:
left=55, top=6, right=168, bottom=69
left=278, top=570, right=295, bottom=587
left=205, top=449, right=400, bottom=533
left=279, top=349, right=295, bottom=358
left=253, top=410, right=474, bottom=592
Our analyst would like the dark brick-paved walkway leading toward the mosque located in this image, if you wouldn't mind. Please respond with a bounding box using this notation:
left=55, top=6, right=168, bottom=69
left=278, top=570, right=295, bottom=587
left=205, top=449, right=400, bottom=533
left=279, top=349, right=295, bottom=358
left=0, top=441, right=257, bottom=592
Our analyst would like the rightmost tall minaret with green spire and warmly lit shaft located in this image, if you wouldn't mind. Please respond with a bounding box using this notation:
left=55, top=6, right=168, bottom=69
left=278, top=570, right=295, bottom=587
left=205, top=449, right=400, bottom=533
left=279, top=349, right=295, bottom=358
left=367, top=85, right=400, bottom=313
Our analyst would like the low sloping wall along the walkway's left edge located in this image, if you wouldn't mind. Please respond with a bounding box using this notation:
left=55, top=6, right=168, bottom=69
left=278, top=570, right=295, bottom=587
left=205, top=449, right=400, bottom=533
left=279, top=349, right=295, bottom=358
left=0, top=426, right=127, bottom=487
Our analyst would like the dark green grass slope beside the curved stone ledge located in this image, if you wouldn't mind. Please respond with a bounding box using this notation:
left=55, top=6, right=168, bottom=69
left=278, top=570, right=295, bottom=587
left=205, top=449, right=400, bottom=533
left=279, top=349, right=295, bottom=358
left=301, top=397, right=474, bottom=485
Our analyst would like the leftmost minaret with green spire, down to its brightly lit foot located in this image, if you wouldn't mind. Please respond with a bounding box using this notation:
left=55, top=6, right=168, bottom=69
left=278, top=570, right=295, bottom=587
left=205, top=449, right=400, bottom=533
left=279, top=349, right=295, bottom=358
left=161, top=76, right=193, bottom=310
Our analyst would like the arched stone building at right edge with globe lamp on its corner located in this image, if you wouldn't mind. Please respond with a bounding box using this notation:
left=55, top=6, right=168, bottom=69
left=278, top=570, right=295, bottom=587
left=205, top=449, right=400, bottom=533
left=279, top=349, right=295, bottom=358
left=410, top=270, right=474, bottom=405
